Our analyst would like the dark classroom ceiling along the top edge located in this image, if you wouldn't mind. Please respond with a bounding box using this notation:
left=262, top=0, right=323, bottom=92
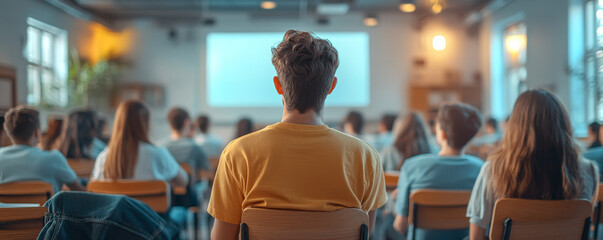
left=55, top=0, right=488, bottom=20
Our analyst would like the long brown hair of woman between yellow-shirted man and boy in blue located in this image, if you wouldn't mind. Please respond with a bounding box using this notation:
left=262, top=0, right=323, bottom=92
left=394, top=112, right=431, bottom=169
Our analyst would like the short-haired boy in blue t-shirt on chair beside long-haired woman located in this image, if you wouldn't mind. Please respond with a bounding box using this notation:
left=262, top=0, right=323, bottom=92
left=394, top=103, right=483, bottom=239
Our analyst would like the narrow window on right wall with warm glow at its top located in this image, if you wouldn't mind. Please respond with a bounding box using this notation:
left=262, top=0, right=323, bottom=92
left=504, top=23, right=528, bottom=112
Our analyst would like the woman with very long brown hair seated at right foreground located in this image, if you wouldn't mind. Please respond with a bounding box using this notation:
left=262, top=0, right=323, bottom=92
left=467, top=90, right=598, bottom=239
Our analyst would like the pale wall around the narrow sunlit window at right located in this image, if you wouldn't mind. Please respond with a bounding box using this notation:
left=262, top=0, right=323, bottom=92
left=479, top=0, right=571, bottom=118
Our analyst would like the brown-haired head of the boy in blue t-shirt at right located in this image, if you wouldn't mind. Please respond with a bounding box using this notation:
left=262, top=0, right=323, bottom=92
left=436, top=103, right=482, bottom=150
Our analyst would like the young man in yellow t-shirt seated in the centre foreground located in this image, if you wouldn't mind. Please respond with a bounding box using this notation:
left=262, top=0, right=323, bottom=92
left=207, top=30, right=387, bottom=239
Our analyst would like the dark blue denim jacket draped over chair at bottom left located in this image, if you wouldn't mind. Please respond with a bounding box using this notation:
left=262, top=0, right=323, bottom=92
left=38, top=192, right=178, bottom=240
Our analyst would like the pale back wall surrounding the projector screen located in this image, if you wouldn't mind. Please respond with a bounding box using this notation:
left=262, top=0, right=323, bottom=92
left=124, top=13, right=479, bottom=139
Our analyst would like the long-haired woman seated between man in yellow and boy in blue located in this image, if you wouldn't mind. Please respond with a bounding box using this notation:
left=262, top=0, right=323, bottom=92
left=381, top=112, right=432, bottom=171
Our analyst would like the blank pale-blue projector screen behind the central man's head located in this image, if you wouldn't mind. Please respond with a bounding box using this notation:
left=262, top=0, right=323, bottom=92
left=206, top=32, right=370, bottom=107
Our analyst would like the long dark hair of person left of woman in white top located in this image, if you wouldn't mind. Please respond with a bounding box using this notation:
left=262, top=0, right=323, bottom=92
left=55, top=110, right=97, bottom=158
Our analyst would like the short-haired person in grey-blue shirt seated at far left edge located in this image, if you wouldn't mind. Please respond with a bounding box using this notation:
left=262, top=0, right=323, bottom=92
left=0, top=106, right=86, bottom=192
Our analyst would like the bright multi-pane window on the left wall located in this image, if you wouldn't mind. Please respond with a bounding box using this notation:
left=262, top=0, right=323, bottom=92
left=25, top=18, right=68, bottom=107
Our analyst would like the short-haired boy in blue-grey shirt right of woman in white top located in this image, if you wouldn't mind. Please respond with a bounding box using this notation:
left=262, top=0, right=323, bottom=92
left=163, top=108, right=209, bottom=173
